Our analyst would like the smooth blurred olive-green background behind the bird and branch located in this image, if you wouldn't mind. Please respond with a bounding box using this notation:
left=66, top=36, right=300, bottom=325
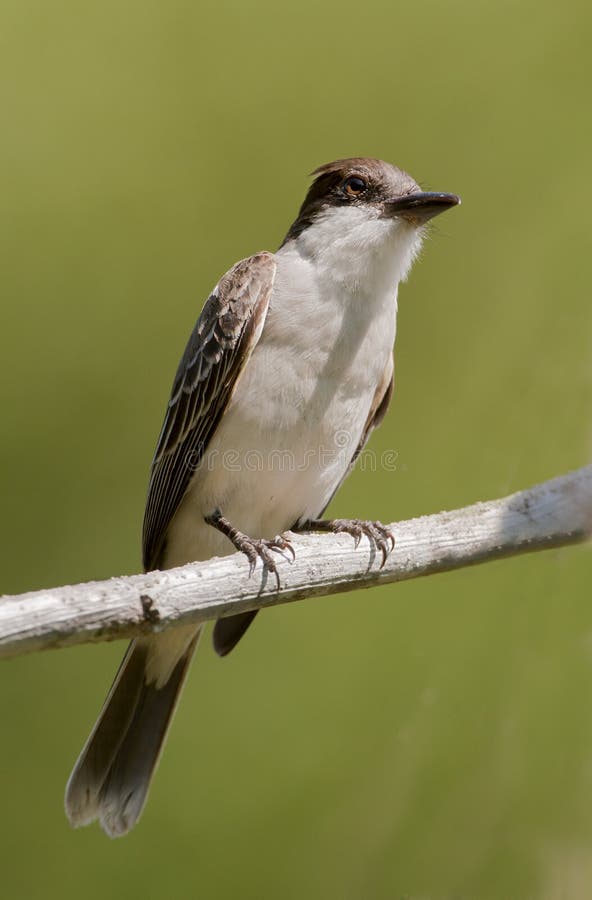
left=0, top=0, right=592, bottom=900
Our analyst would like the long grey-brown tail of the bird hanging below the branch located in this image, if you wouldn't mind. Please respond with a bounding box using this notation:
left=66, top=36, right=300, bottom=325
left=65, top=626, right=200, bottom=837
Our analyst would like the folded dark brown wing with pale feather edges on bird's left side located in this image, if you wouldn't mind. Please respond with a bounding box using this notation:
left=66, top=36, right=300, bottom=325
left=142, top=253, right=275, bottom=570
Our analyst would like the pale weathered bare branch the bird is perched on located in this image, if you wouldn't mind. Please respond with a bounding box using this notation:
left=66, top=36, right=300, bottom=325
left=0, top=466, right=592, bottom=657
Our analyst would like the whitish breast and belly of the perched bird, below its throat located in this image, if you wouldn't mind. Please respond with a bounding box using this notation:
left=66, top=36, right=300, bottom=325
left=165, top=214, right=420, bottom=567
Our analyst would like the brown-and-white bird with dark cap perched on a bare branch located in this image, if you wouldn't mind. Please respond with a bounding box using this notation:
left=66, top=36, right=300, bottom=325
left=65, top=157, right=460, bottom=837
